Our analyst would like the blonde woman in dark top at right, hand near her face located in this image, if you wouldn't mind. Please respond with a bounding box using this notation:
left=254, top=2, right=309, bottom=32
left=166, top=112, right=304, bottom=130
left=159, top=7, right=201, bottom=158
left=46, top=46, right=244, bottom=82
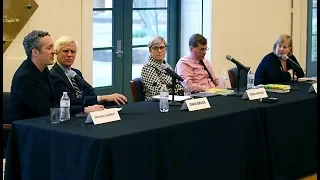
left=254, top=34, right=304, bottom=85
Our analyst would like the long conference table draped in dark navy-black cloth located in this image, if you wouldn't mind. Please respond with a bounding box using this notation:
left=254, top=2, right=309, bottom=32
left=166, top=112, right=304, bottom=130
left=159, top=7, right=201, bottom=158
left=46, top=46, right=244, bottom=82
left=5, top=83, right=317, bottom=180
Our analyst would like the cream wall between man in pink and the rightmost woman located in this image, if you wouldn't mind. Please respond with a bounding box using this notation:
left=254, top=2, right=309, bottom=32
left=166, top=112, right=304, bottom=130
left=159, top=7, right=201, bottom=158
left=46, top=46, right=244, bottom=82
left=210, top=0, right=291, bottom=75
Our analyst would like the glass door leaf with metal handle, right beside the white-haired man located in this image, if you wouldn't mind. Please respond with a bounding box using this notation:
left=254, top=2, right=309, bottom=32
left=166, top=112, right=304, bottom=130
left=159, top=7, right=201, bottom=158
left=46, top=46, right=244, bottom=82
left=92, top=0, right=124, bottom=94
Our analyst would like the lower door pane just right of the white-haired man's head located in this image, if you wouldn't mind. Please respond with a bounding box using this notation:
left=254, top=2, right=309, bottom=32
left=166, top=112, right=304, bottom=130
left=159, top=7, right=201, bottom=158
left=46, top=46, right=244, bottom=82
left=93, top=50, right=113, bottom=87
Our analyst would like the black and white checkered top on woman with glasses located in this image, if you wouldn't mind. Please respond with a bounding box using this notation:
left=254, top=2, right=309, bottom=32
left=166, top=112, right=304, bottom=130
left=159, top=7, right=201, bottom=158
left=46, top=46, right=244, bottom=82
left=141, top=56, right=183, bottom=101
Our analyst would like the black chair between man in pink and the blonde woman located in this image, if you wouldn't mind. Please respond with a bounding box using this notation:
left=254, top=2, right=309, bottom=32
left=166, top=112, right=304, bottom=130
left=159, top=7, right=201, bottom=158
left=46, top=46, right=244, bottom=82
left=228, top=67, right=250, bottom=88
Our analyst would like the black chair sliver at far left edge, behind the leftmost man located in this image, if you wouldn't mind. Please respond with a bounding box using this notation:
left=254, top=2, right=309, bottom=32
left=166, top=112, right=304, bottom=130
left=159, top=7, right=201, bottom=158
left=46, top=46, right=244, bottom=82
left=2, top=92, right=11, bottom=158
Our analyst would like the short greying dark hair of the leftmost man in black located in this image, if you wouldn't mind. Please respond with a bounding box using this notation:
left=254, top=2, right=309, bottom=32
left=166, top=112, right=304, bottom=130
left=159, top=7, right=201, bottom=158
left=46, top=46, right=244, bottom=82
left=23, top=30, right=50, bottom=57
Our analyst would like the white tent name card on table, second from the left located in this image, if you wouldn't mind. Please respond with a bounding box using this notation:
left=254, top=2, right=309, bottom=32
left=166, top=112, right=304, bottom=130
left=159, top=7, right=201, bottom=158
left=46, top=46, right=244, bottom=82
left=180, top=97, right=211, bottom=111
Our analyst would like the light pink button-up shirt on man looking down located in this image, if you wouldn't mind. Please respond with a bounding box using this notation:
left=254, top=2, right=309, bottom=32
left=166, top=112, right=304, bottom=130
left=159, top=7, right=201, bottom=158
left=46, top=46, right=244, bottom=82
left=176, top=56, right=219, bottom=92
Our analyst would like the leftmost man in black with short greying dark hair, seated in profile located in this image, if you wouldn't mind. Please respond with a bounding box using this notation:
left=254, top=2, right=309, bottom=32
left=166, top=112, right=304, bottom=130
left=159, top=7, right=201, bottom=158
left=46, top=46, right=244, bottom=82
left=9, top=30, right=57, bottom=121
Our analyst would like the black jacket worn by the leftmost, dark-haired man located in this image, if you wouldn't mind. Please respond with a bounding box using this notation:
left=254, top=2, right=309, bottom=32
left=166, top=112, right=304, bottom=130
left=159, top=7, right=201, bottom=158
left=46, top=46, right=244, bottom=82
left=9, top=58, right=58, bottom=122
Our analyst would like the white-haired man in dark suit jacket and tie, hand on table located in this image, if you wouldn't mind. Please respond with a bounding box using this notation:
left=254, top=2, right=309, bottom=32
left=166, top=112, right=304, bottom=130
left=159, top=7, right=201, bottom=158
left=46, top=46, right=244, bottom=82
left=50, top=36, right=127, bottom=114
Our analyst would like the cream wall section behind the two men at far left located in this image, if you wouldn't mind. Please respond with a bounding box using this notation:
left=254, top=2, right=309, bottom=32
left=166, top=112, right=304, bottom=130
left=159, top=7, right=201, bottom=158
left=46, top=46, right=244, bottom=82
left=3, top=0, right=82, bottom=92
